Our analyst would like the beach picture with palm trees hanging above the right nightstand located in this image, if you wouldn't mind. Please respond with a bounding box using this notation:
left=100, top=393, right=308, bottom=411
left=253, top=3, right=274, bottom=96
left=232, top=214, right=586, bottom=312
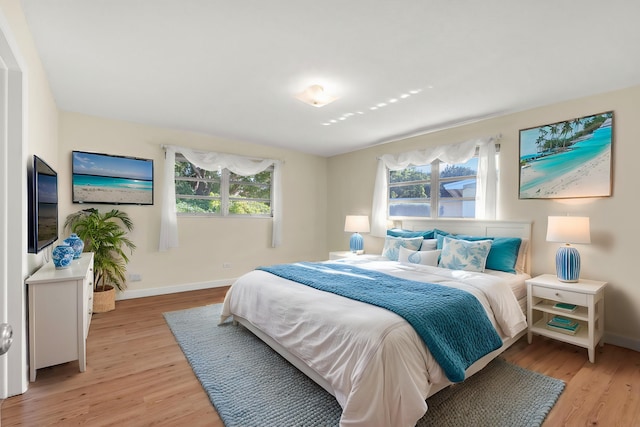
left=519, top=111, right=613, bottom=199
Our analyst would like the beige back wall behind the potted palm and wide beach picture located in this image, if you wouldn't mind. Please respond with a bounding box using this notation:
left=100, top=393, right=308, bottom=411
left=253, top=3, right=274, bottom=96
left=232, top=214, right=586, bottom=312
left=57, top=112, right=327, bottom=297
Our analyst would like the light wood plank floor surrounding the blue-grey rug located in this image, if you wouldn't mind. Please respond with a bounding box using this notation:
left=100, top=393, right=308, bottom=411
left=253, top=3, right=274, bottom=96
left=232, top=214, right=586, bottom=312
left=0, top=288, right=640, bottom=427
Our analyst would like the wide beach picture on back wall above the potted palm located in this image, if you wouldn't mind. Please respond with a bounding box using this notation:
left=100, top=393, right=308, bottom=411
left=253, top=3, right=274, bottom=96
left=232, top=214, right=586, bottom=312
left=72, top=151, right=153, bottom=205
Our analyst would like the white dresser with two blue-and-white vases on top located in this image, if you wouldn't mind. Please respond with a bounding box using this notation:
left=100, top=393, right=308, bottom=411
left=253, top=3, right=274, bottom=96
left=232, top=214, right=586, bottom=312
left=26, top=253, right=93, bottom=381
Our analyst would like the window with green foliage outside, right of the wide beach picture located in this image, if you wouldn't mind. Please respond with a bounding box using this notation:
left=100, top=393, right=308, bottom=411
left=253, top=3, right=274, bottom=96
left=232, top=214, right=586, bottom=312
left=175, top=153, right=273, bottom=217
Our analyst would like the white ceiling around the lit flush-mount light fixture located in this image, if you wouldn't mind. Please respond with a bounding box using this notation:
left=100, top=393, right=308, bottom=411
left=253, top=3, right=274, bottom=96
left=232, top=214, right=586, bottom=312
left=21, top=0, right=640, bottom=156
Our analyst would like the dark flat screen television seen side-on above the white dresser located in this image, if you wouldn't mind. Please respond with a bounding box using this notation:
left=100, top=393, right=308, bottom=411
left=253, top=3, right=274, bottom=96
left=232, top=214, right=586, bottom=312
left=28, top=156, right=58, bottom=254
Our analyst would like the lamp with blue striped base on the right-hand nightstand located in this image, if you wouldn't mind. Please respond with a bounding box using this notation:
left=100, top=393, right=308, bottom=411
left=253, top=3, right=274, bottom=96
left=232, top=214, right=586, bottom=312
left=547, top=216, right=591, bottom=282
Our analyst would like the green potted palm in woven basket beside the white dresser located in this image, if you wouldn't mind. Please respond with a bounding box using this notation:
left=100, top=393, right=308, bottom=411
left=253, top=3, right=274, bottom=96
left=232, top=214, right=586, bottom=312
left=64, top=208, right=136, bottom=313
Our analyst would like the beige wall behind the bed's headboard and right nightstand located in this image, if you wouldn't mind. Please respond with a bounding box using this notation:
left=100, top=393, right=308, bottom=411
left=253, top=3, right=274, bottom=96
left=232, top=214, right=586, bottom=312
left=327, top=86, right=640, bottom=350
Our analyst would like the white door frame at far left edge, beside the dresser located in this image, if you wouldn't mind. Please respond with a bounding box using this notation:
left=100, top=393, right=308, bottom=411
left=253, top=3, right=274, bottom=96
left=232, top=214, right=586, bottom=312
left=0, top=11, right=28, bottom=399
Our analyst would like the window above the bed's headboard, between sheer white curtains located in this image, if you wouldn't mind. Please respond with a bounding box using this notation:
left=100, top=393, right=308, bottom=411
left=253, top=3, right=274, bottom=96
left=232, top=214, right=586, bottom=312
left=388, top=157, right=478, bottom=218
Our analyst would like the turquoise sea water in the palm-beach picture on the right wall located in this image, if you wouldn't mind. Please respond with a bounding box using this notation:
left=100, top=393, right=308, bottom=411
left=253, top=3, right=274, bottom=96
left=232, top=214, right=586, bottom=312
left=520, top=122, right=612, bottom=193
